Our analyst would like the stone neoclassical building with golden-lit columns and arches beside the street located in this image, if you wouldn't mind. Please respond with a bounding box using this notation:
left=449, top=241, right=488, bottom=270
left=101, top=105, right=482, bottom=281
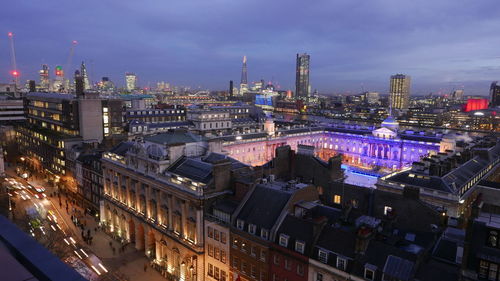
left=101, top=130, right=250, bottom=280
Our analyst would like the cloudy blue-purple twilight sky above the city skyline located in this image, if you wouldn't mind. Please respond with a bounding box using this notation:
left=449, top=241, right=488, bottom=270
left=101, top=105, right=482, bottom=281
left=0, top=0, right=500, bottom=95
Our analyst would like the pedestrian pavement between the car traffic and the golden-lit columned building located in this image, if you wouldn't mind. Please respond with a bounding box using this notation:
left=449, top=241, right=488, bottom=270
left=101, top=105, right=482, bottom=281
left=6, top=164, right=166, bottom=281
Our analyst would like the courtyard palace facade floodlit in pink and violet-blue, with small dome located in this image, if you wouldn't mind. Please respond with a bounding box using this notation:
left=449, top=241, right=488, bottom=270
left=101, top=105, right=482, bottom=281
left=221, top=117, right=455, bottom=170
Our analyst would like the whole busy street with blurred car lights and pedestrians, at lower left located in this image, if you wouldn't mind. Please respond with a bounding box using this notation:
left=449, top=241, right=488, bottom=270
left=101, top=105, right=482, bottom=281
left=6, top=164, right=165, bottom=281
